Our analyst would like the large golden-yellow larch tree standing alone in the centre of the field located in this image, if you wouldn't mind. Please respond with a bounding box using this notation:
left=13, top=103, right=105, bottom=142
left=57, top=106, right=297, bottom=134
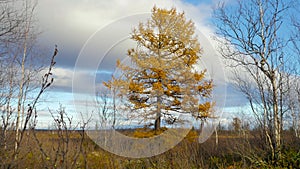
left=104, top=7, right=213, bottom=130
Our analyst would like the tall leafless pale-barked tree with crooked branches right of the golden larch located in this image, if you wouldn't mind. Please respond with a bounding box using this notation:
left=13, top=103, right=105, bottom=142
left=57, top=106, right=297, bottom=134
left=215, top=0, right=292, bottom=161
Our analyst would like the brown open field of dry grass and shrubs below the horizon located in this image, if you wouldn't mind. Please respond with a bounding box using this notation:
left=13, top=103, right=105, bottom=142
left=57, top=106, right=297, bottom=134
left=0, top=130, right=300, bottom=169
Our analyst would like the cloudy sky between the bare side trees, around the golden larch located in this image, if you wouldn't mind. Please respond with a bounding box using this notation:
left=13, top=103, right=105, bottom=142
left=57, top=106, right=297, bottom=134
left=36, top=0, right=246, bottom=127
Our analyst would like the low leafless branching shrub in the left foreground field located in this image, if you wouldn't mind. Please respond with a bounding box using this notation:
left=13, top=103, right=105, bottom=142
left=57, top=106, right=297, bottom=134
left=33, top=105, right=91, bottom=168
